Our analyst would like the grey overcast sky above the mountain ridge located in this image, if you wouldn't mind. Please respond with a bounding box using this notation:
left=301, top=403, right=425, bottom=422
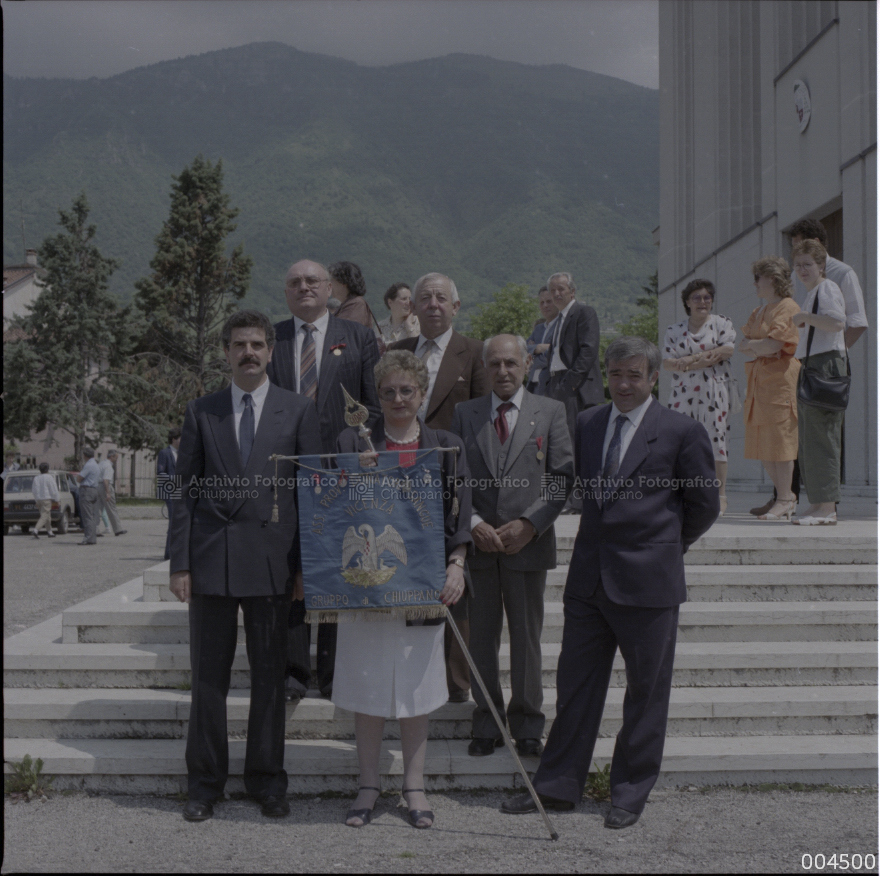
left=0, top=0, right=659, bottom=88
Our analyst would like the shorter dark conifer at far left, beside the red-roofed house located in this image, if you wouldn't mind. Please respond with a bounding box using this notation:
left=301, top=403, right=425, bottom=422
left=3, top=192, right=130, bottom=459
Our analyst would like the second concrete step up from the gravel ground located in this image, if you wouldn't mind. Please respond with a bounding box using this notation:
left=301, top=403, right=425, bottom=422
left=3, top=685, right=877, bottom=739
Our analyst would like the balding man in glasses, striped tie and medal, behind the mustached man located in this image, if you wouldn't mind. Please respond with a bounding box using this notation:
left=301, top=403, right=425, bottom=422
left=268, top=259, right=380, bottom=700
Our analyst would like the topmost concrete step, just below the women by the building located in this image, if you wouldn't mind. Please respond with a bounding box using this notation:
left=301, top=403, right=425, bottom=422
left=556, top=523, right=877, bottom=566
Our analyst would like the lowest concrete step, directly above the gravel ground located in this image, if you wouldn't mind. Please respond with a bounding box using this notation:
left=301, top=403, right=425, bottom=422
left=4, top=735, right=877, bottom=796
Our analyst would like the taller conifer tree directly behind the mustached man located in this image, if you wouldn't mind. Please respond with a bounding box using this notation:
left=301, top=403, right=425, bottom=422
left=128, top=155, right=252, bottom=446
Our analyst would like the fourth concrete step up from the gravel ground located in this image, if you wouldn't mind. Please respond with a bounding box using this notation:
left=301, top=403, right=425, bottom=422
left=62, top=600, right=877, bottom=644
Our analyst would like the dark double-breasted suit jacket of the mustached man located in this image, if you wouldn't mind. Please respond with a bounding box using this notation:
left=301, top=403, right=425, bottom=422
left=171, top=384, right=321, bottom=596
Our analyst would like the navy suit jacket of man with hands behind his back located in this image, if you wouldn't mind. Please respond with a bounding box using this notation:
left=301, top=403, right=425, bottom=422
left=565, top=399, right=720, bottom=608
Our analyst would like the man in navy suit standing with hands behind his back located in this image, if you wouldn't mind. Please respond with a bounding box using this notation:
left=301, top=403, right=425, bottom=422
left=502, top=337, right=719, bottom=828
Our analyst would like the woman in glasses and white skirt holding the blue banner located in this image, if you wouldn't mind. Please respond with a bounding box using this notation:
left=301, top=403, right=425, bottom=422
left=332, top=350, right=473, bottom=828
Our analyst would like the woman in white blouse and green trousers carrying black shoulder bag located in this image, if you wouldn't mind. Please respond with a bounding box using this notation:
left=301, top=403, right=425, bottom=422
left=791, top=240, right=846, bottom=526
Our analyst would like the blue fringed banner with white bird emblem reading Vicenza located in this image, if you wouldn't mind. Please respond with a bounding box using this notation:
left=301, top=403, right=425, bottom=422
left=297, top=448, right=446, bottom=622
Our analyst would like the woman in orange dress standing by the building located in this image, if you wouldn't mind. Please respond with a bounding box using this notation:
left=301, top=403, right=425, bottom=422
left=739, top=256, right=801, bottom=520
